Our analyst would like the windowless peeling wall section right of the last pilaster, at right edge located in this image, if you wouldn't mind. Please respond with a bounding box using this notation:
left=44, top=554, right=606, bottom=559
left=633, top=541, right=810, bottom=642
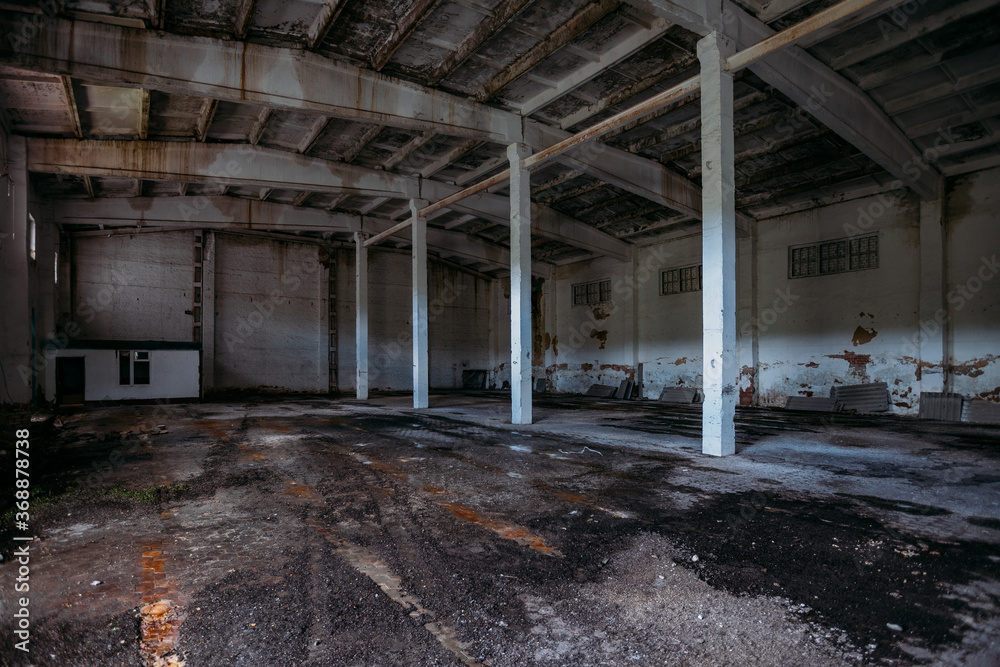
left=945, top=169, right=1000, bottom=402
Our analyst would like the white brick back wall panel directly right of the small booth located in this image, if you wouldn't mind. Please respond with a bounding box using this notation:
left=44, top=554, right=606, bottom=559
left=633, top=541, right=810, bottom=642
left=214, top=233, right=329, bottom=392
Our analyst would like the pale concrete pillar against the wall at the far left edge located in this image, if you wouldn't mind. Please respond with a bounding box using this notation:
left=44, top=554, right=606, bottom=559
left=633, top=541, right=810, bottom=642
left=0, top=131, right=31, bottom=404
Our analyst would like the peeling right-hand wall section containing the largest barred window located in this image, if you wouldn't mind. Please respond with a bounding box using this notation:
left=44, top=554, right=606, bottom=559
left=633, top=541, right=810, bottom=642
left=757, top=193, right=920, bottom=413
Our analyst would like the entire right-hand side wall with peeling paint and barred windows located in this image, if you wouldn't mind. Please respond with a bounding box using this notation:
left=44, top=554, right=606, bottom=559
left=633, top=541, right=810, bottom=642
left=545, top=169, right=1000, bottom=415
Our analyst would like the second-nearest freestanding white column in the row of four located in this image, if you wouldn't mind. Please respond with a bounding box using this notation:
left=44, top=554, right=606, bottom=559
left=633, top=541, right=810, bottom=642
left=507, top=144, right=531, bottom=424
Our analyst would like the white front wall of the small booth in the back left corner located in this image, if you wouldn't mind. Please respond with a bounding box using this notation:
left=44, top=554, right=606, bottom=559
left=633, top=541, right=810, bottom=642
left=45, top=349, right=199, bottom=401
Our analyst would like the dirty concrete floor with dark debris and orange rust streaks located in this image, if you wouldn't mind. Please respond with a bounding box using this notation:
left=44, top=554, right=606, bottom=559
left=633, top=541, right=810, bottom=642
left=0, top=393, right=1000, bottom=667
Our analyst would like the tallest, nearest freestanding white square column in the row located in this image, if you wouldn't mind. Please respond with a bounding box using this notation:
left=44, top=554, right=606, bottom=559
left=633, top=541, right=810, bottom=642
left=698, top=32, right=739, bottom=456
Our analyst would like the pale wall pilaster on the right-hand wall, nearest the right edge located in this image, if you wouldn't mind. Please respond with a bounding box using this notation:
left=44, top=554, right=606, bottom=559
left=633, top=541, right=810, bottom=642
left=920, top=199, right=948, bottom=392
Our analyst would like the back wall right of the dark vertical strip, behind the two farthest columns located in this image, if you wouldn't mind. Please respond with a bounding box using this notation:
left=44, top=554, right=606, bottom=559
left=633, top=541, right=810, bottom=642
left=337, top=248, right=496, bottom=391
